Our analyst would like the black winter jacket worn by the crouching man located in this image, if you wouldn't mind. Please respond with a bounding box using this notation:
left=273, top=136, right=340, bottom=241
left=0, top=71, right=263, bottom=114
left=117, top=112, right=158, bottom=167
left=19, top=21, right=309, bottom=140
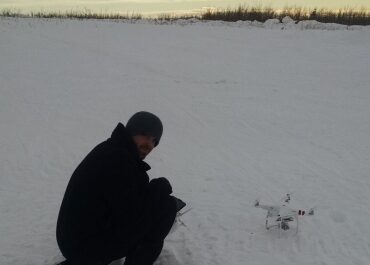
left=57, top=123, right=155, bottom=253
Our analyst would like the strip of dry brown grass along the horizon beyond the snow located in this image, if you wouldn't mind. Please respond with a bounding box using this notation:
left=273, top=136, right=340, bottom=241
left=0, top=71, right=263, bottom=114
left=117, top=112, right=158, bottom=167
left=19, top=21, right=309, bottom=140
left=0, top=6, right=370, bottom=25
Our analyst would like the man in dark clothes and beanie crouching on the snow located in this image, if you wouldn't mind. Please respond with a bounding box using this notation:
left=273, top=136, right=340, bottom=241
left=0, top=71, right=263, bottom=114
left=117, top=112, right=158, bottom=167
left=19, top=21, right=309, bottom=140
left=57, top=111, right=176, bottom=265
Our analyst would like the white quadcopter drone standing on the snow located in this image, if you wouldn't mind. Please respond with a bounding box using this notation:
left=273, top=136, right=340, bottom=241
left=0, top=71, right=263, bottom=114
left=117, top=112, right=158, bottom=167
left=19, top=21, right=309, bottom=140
left=254, top=194, right=314, bottom=233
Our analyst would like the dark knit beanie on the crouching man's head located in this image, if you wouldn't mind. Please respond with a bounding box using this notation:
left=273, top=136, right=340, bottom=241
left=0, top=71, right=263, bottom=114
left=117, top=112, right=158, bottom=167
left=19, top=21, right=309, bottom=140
left=126, top=111, right=163, bottom=146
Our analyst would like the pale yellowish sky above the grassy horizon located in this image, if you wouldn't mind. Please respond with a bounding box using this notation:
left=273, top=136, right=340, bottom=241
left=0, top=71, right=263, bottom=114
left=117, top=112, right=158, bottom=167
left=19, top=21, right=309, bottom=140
left=0, top=0, right=370, bottom=14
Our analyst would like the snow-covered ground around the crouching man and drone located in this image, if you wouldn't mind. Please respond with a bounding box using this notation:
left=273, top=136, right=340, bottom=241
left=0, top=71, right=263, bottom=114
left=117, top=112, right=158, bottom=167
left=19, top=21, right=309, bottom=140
left=0, top=18, right=370, bottom=265
